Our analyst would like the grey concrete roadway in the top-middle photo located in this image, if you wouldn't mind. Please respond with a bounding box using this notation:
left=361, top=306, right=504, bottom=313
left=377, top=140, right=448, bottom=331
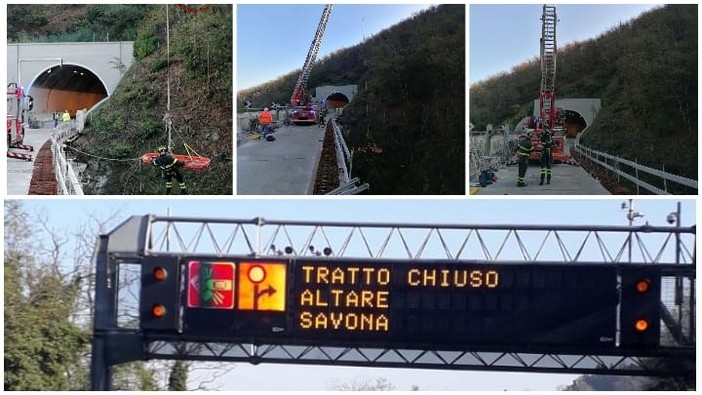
left=236, top=125, right=324, bottom=195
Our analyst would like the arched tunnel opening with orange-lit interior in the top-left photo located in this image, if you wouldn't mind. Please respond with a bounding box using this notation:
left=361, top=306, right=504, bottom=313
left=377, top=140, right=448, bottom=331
left=29, top=64, right=107, bottom=116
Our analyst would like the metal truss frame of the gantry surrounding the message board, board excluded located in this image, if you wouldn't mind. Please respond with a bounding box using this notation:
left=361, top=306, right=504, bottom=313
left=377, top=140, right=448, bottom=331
left=91, top=216, right=696, bottom=389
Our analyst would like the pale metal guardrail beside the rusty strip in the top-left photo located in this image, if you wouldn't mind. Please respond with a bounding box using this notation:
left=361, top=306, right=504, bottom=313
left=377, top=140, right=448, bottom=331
left=51, top=110, right=86, bottom=195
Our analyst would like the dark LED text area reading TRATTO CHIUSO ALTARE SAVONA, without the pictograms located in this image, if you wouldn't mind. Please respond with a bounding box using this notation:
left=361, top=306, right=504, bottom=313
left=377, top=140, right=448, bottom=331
left=290, top=261, right=618, bottom=347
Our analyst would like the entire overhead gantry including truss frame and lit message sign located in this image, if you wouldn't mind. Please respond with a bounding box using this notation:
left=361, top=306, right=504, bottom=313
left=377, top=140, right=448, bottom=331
left=92, top=216, right=695, bottom=389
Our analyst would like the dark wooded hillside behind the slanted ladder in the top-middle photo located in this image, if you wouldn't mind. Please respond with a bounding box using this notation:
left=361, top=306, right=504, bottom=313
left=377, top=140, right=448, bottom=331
left=238, top=5, right=465, bottom=195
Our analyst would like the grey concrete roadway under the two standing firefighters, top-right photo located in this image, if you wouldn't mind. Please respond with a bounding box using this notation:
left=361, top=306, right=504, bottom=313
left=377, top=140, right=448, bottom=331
left=471, top=164, right=610, bottom=195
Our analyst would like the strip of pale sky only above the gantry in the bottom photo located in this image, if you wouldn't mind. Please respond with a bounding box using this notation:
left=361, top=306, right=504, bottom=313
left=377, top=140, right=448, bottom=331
left=16, top=197, right=695, bottom=234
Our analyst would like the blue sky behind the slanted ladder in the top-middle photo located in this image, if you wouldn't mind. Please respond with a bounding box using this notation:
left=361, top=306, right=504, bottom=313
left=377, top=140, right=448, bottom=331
left=236, top=4, right=429, bottom=90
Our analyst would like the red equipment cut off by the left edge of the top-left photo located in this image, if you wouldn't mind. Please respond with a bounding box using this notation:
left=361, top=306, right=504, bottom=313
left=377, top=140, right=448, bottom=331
left=7, top=82, right=34, bottom=161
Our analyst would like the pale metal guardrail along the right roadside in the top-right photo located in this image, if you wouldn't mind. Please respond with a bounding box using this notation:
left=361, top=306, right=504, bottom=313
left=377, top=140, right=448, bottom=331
left=574, top=145, right=698, bottom=195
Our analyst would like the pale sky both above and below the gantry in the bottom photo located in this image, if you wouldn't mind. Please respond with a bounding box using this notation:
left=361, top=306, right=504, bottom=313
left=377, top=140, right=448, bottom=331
left=11, top=197, right=696, bottom=390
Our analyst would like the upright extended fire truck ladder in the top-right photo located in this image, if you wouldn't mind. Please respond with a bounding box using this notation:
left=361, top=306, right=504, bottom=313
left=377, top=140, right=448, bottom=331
left=530, top=5, right=570, bottom=162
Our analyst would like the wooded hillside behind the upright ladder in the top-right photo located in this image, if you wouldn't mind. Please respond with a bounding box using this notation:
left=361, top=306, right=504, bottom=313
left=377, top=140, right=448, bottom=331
left=470, top=4, right=699, bottom=179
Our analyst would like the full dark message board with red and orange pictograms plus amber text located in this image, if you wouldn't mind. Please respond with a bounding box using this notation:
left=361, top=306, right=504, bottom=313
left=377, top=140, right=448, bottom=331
left=172, top=259, right=619, bottom=348
